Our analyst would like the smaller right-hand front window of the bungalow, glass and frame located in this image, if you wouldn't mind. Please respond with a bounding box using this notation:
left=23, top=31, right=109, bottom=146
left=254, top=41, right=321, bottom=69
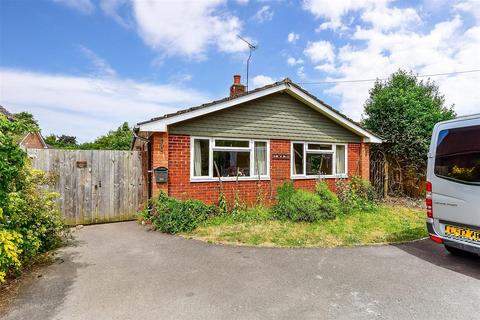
left=291, top=142, right=347, bottom=177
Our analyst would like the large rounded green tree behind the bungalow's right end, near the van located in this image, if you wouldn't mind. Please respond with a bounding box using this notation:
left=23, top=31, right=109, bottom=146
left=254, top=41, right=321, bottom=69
left=363, top=70, right=456, bottom=171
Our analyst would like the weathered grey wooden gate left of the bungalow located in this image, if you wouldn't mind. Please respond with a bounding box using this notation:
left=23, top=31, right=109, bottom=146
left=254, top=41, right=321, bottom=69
left=28, top=149, right=146, bottom=225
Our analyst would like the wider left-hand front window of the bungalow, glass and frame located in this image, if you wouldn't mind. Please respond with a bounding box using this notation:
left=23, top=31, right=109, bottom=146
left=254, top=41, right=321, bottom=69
left=191, top=137, right=269, bottom=180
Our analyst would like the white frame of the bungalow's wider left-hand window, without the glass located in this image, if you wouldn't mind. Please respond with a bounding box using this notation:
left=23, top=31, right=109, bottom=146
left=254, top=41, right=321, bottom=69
left=190, top=136, right=270, bottom=182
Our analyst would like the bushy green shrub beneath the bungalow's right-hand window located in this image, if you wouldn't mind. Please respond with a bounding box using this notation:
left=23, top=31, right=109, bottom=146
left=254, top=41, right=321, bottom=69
left=272, top=182, right=338, bottom=222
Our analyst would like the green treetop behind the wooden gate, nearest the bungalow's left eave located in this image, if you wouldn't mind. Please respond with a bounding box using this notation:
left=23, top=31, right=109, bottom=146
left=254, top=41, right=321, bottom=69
left=80, top=122, right=133, bottom=150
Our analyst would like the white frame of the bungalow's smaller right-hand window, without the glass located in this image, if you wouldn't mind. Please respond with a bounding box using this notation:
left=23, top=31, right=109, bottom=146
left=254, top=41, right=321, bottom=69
left=290, top=141, right=348, bottom=179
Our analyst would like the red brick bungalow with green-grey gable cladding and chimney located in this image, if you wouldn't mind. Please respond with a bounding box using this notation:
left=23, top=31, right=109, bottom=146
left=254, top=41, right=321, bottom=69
left=132, top=76, right=381, bottom=204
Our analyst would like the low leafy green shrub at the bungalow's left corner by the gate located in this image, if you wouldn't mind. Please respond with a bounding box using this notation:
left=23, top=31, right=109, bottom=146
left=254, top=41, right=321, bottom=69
left=152, top=193, right=214, bottom=234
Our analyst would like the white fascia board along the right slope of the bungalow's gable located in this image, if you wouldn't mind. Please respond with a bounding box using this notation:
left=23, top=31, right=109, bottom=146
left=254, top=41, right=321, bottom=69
left=287, top=87, right=382, bottom=143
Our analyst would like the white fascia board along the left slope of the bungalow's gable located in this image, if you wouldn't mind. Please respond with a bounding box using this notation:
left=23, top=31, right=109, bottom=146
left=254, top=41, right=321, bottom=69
left=138, top=84, right=287, bottom=132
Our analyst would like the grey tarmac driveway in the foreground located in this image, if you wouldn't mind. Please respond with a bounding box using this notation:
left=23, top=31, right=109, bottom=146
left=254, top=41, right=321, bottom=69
left=1, top=222, right=480, bottom=320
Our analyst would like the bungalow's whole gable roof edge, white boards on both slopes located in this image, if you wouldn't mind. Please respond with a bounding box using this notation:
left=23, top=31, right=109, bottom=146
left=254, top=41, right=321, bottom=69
left=135, top=78, right=382, bottom=143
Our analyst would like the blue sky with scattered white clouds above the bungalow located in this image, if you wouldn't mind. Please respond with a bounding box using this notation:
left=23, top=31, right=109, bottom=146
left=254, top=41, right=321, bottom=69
left=0, top=0, right=480, bottom=142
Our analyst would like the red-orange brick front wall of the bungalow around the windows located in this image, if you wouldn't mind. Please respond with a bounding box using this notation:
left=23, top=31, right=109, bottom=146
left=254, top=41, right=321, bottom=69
left=151, top=133, right=369, bottom=205
